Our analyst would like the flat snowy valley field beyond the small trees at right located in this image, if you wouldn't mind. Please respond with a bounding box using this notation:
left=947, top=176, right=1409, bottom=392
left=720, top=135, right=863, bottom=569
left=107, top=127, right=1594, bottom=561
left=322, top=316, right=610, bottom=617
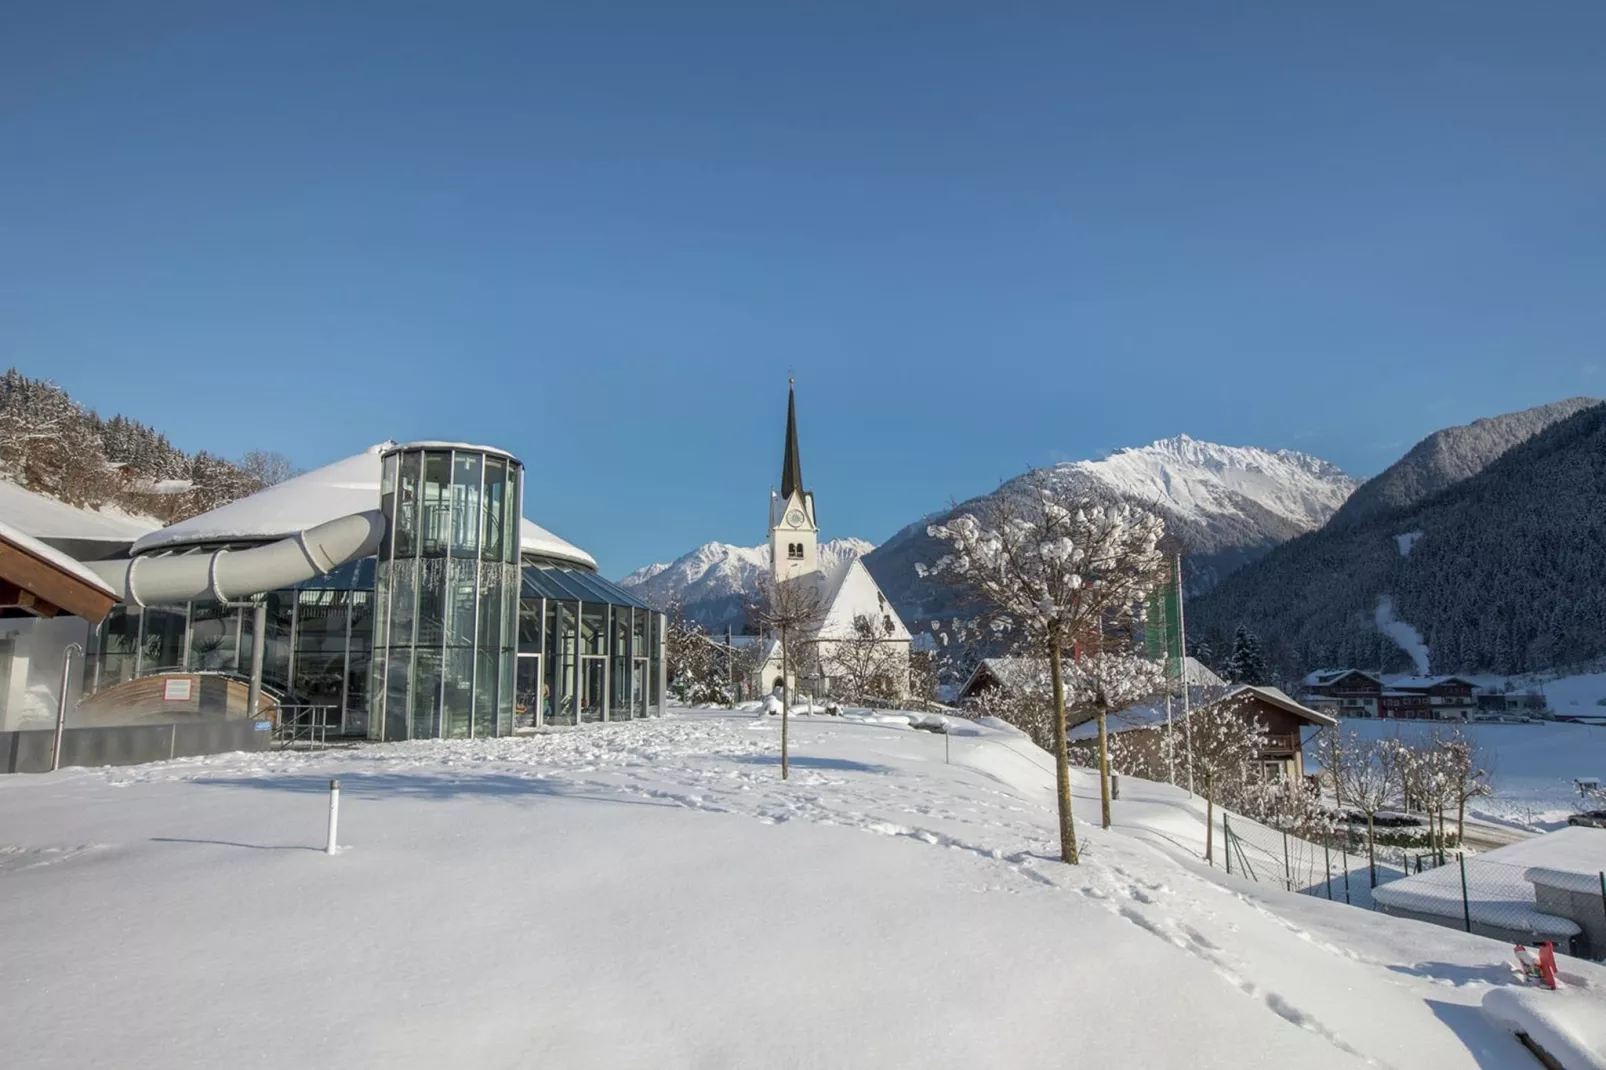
left=1306, top=718, right=1606, bottom=832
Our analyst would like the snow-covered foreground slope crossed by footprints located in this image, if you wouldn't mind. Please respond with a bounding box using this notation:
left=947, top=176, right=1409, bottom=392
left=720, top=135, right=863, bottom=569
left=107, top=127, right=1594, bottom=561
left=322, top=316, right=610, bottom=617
left=0, top=712, right=1606, bottom=1070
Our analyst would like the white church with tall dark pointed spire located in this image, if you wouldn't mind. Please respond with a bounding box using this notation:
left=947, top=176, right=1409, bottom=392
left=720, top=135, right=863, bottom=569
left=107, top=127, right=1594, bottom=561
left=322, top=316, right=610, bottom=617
left=756, top=382, right=909, bottom=700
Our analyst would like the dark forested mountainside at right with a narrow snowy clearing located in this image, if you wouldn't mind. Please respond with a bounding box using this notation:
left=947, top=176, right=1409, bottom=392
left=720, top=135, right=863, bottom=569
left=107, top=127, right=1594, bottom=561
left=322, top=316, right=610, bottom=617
left=1190, top=403, right=1606, bottom=675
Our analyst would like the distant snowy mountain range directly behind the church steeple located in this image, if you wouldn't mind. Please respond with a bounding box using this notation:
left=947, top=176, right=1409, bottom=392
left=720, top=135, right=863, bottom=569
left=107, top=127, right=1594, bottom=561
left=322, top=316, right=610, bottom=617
left=618, top=538, right=875, bottom=628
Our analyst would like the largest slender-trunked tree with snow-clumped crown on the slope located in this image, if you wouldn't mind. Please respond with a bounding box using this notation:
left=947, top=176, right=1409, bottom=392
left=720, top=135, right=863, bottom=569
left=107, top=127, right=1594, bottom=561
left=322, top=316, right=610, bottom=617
left=917, top=471, right=1166, bottom=864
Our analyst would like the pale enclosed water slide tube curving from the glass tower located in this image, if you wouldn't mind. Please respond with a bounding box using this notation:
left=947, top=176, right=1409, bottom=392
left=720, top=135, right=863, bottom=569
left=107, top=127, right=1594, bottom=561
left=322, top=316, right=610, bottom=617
left=84, top=509, right=385, bottom=606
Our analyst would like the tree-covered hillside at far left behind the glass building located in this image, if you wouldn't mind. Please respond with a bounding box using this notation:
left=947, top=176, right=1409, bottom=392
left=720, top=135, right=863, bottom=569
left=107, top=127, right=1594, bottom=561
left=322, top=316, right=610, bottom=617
left=0, top=368, right=291, bottom=524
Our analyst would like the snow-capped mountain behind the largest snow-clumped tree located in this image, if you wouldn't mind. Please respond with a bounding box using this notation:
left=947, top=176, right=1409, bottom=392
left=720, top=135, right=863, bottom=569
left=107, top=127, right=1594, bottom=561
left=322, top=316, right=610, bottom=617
left=864, top=435, right=1359, bottom=620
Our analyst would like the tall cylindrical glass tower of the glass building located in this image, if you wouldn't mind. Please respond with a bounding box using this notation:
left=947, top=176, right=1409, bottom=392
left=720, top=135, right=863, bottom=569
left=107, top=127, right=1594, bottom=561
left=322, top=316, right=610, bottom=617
left=368, top=447, right=524, bottom=739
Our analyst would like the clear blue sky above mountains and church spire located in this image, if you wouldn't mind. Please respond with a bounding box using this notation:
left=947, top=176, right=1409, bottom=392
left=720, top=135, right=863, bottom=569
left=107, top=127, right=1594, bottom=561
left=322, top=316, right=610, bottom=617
left=0, top=0, right=1606, bottom=575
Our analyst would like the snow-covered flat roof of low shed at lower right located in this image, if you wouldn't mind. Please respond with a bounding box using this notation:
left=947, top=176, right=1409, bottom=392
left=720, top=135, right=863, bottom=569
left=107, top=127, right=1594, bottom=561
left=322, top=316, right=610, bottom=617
left=1372, top=827, right=1606, bottom=937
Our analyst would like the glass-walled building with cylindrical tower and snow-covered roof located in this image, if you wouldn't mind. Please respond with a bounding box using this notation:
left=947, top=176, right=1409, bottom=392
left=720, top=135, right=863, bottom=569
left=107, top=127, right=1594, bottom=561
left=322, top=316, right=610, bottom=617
left=84, top=443, right=665, bottom=741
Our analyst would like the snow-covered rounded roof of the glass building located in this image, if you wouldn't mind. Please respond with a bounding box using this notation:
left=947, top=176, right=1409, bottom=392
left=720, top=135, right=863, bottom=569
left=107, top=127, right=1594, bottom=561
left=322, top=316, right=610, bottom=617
left=133, top=442, right=597, bottom=569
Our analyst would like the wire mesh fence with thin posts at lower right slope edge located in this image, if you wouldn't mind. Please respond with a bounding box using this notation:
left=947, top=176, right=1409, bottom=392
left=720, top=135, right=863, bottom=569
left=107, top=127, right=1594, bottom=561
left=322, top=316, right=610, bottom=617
left=1221, top=813, right=1606, bottom=959
